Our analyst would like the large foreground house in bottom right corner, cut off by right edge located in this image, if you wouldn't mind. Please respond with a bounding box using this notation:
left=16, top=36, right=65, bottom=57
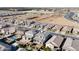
left=62, top=38, right=79, bottom=51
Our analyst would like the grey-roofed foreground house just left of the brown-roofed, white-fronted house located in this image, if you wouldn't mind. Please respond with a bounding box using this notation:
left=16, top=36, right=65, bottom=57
left=33, top=32, right=52, bottom=44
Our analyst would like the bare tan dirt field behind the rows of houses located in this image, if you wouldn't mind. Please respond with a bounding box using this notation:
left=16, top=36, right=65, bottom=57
left=36, top=16, right=79, bottom=28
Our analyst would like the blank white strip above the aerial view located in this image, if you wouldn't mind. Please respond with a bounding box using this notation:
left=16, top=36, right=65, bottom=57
left=0, top=0, right=79, bottom=7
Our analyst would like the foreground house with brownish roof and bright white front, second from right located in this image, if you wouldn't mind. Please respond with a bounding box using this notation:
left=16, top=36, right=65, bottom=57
left=46, top=35, right=64, bottom=50
